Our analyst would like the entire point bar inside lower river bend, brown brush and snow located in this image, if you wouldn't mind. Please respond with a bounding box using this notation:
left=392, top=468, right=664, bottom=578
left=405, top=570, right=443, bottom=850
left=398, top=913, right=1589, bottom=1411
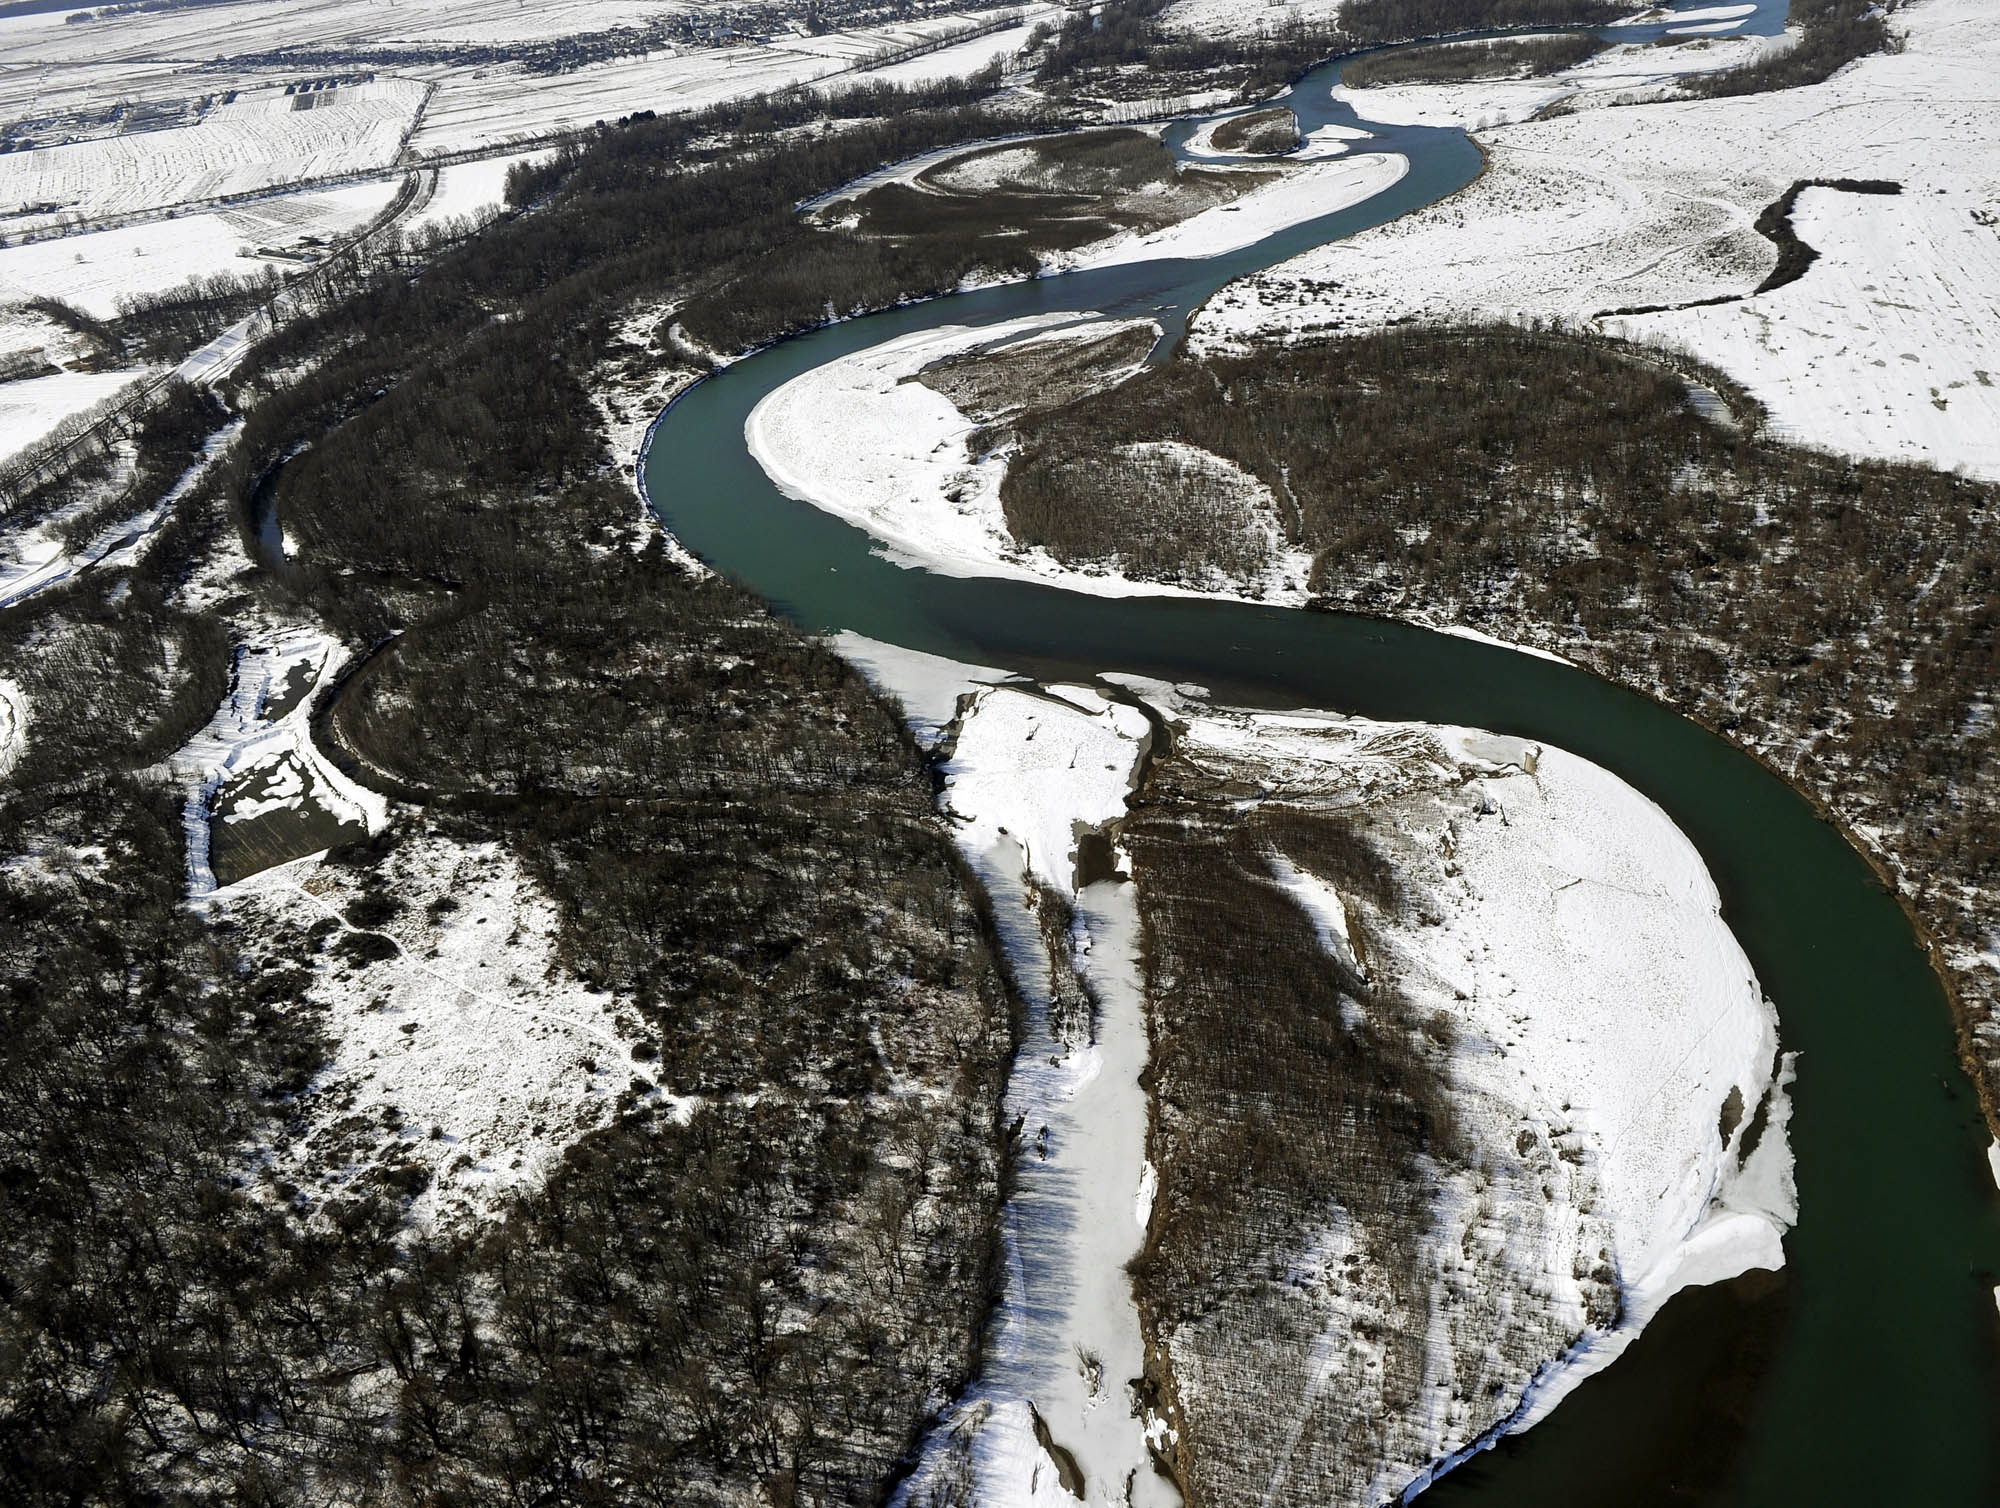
left=1130, top=686, right=1796, bottom=1504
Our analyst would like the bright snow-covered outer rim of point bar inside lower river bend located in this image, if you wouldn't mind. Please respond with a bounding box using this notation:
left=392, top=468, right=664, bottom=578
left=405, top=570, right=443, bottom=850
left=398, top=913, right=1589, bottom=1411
left=1130, top=682, right=1796, bottom=1504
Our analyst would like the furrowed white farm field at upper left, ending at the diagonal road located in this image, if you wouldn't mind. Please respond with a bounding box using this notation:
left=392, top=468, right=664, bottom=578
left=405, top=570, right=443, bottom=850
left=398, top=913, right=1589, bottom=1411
left=0, top=78, right=426, bottom=224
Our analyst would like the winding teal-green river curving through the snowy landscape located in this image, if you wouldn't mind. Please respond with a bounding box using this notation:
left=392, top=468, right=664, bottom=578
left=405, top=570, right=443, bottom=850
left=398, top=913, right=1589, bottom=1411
left=646, top=20, right=2000, bottom=1508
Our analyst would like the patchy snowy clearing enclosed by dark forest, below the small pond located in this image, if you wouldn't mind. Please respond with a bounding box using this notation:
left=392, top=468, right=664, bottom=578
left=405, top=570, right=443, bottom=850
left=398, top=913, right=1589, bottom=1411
left=206, top=832, right=652, bottom=1228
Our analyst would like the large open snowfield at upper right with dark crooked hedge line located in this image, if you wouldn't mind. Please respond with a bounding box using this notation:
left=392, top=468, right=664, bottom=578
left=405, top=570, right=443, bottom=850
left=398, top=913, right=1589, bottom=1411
left=1192, top=0, right=2000, bottom=476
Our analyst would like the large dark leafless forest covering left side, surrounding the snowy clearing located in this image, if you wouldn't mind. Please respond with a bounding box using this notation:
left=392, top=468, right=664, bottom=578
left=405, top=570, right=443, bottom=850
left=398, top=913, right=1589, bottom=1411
left=0, top=64, right=1064, bottom=1504
